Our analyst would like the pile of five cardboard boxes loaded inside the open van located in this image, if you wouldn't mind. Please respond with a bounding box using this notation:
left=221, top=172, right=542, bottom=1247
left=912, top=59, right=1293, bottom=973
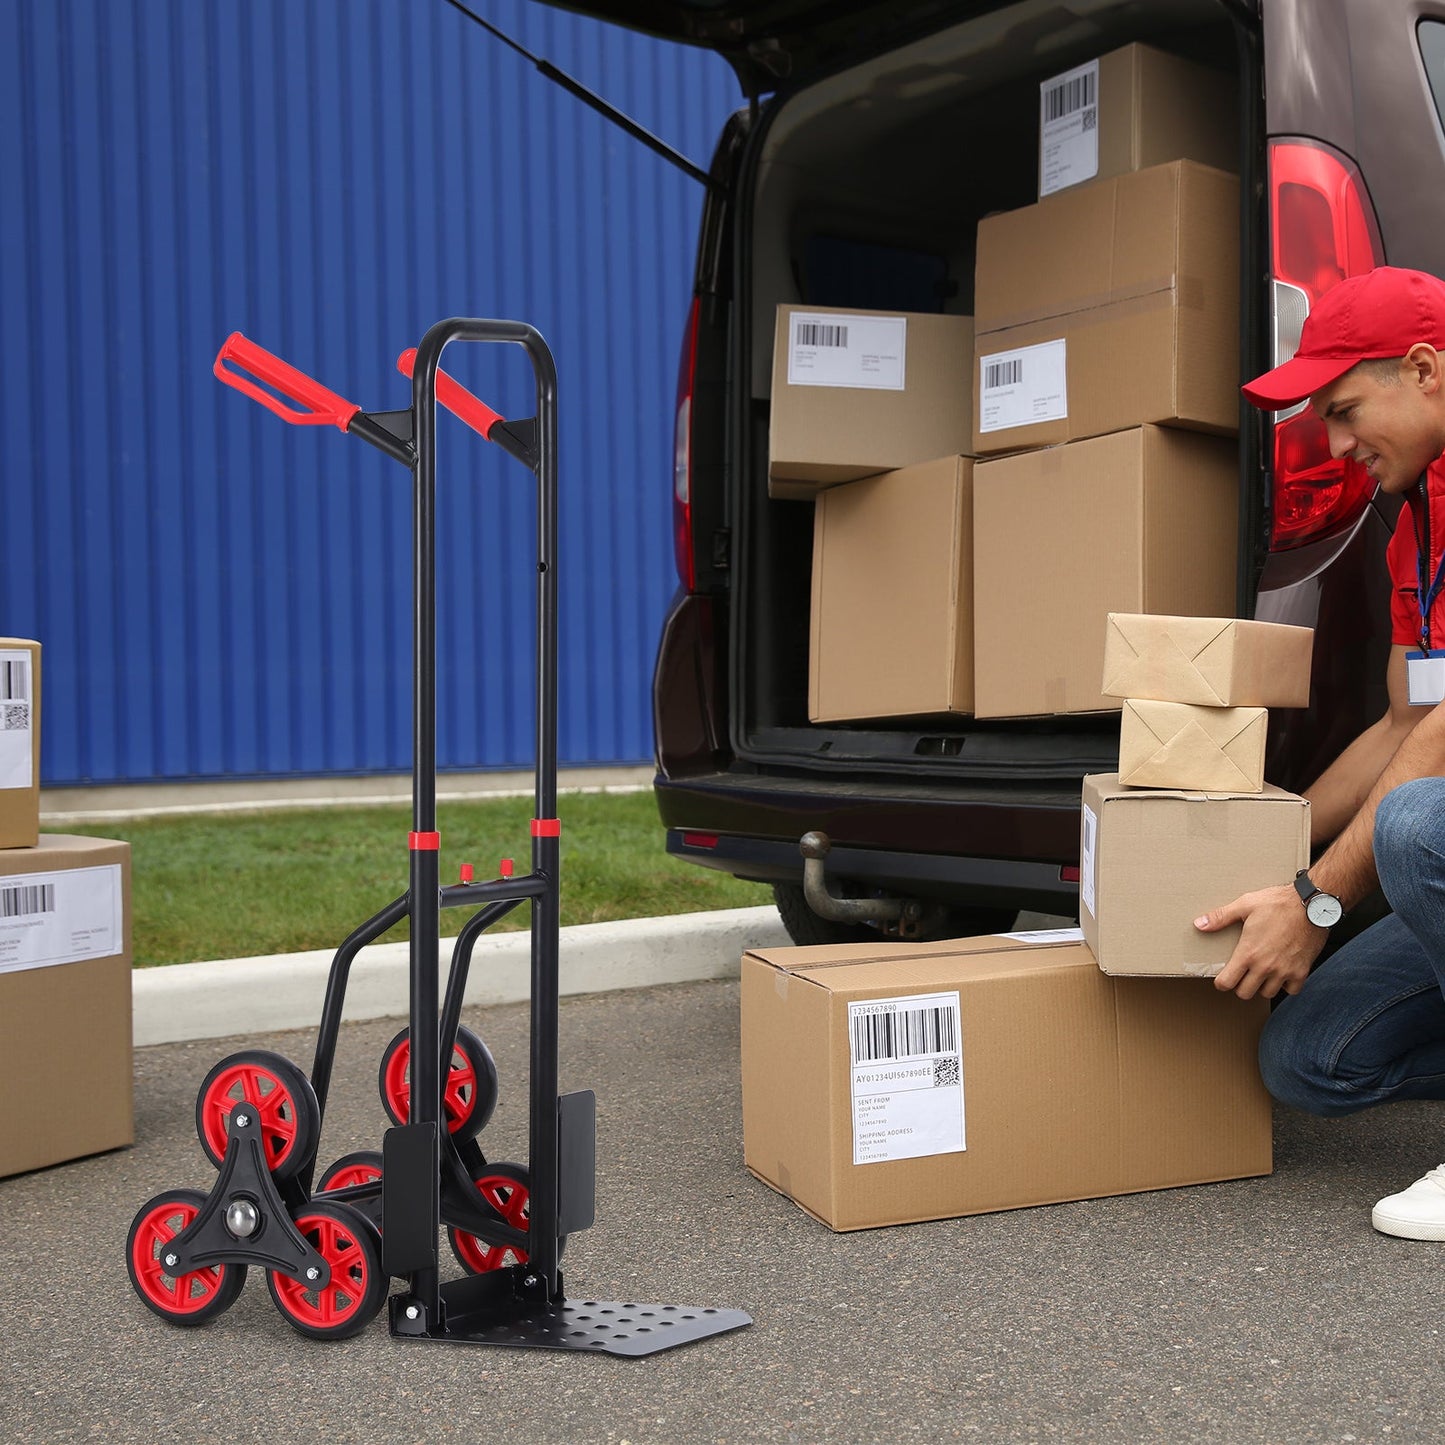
left=769, top=45, right=1240, bottom=723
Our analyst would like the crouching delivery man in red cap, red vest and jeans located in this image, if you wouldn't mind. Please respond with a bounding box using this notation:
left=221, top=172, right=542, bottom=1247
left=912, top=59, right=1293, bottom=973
left=1195, top=266, right=1445, bottom=1240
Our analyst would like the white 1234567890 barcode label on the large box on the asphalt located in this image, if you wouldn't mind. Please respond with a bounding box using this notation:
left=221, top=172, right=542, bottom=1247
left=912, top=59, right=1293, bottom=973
left=848, top=990, right=964, bottom=1165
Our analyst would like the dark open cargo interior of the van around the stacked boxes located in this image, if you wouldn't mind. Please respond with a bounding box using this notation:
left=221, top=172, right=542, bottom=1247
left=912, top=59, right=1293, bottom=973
left=733, top=3, right=1240, bottom=792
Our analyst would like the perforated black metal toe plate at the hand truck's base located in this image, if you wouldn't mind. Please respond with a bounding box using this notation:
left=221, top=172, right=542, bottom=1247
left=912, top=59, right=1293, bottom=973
left=432, top=1299, right=753, bottom=1355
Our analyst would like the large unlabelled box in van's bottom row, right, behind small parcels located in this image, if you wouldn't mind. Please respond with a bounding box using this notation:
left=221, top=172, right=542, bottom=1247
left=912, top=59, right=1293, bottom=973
left=974, top=426, right=1238, bottom=717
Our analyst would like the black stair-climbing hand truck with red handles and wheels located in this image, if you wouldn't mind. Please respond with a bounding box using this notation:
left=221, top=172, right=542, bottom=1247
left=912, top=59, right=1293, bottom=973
left=126, top=318, right=751, bottom=1355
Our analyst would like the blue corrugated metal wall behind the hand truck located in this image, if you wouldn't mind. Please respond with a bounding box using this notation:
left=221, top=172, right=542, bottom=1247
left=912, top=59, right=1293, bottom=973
left=0, top=0, right=737, bottom=786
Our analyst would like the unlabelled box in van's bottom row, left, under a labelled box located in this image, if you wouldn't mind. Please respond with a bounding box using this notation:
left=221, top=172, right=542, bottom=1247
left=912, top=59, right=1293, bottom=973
left=808, top=457, right=974, bottom=723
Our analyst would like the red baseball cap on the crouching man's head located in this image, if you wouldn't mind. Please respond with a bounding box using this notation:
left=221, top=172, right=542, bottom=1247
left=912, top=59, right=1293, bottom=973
left=1243, top=266, right=1445, bottom=412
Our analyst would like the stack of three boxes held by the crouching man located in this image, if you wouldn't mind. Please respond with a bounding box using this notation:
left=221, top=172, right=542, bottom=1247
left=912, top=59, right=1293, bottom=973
left=1079, top=614, right=1314, bottom=977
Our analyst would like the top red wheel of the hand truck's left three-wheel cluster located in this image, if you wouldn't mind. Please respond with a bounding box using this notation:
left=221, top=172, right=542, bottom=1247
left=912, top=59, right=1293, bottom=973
left=195, top=1049, right=321, bottom=1179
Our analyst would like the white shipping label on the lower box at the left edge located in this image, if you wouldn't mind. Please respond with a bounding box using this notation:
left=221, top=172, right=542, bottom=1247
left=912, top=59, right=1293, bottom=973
left=0, top=863, right=126, bottom=974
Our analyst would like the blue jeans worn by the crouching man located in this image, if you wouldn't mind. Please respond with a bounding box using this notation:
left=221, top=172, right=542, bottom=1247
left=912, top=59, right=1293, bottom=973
left=1260, top=777, right=1445, bottom=1117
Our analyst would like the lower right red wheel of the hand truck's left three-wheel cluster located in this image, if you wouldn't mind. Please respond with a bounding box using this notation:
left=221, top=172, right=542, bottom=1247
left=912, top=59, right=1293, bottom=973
left=266, top=1199, right=392, bottom=1340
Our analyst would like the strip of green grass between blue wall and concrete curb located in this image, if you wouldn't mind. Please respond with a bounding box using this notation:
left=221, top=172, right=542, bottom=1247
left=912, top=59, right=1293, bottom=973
left=62, top=792, right=772, bottom=967
